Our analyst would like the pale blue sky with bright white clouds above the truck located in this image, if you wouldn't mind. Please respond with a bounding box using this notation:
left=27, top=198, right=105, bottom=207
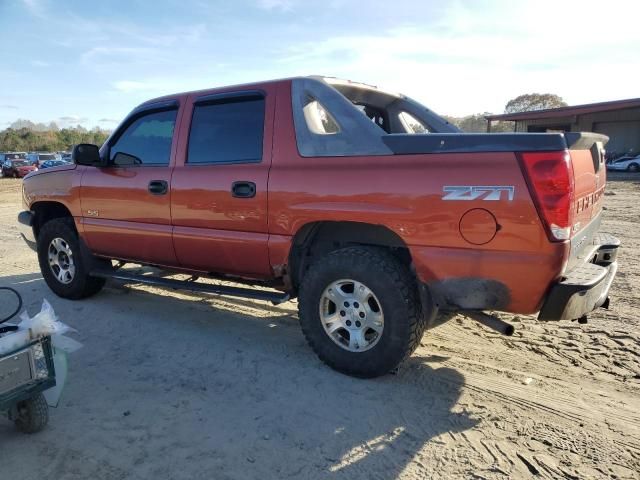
left=0, top=0, right=640, bottom=129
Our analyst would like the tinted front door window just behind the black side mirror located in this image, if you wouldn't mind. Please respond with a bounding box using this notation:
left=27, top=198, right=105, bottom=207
left=109, top=110, right=177, bottom=166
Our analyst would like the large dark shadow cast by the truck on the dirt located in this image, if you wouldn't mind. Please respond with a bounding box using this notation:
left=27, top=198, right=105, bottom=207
left=0, top=275, right=477, bottom=478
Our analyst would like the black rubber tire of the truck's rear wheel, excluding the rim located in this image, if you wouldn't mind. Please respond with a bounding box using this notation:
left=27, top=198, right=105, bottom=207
left=299, top=247, right=428, bottom=378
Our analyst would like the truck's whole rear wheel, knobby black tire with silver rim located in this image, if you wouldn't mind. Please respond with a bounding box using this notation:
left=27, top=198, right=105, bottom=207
left=299, top=247, right=426, bottom=378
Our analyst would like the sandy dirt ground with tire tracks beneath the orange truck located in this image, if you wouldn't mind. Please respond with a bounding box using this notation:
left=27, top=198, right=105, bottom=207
left=0, top=175, right=640, bottom=480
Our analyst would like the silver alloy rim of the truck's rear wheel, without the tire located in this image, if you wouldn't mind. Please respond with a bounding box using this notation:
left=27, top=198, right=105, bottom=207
left=320, top=279, right=384, bottom=352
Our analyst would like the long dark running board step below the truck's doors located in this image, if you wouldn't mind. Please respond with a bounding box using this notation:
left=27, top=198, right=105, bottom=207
left=90, top=270, right=289, bottom=305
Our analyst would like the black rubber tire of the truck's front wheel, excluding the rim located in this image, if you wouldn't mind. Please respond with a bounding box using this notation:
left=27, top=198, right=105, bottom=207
left=37, top=218, right=105, bottom=300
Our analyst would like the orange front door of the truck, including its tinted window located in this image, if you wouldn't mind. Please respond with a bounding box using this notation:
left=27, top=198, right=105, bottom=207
left=80, top=101, right=179, bottom=266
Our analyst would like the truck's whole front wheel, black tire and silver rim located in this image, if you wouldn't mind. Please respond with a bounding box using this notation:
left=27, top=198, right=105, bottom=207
left=37, top=218, right=106, bottom=300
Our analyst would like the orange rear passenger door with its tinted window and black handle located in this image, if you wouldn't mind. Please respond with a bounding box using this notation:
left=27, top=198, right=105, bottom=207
left=171, top=88, right=275, bottom=278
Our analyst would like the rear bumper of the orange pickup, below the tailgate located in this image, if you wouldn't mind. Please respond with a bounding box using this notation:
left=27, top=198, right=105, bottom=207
left=538, top=234, right=620, bottom=321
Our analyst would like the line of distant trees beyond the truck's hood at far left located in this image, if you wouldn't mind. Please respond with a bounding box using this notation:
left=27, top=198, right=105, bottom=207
left=0, top=120, right=110, bottom=152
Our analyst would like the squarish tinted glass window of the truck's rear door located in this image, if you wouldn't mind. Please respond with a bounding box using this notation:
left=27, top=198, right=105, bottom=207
left=187, top=97, right=264, bottom=165
